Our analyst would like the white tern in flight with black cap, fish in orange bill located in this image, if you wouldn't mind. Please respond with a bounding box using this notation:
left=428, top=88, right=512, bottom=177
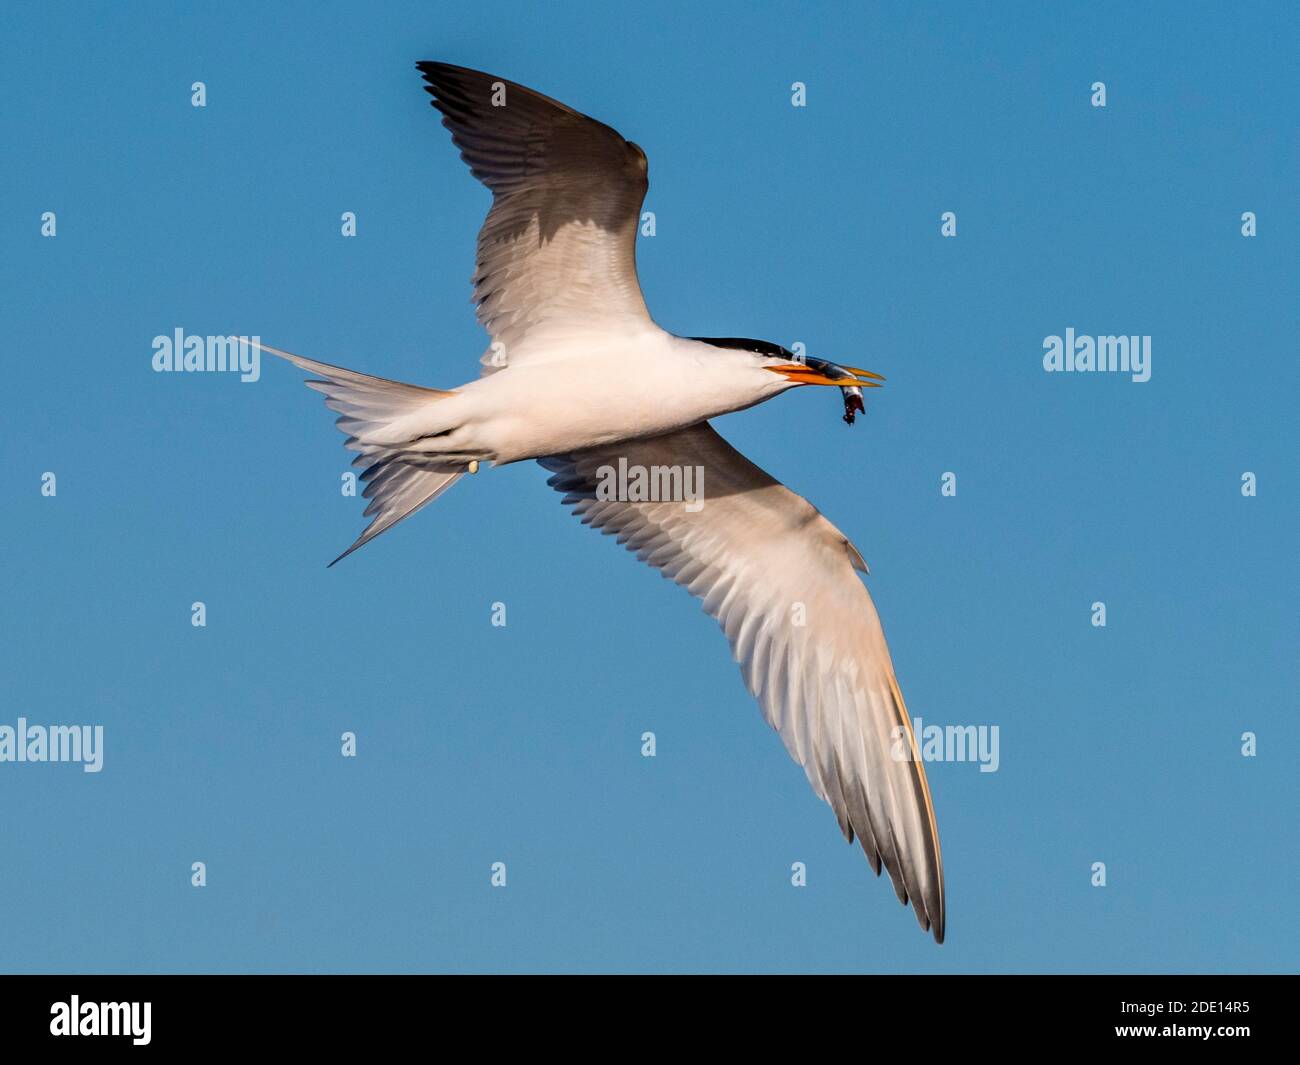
left=264, top=62, right=944, bottom=943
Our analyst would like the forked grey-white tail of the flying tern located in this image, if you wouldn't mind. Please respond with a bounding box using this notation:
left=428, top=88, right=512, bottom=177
left=257, top=343, right=464, bottom=566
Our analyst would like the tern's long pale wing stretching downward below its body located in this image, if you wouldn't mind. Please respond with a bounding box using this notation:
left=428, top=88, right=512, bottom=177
left=541, top=423, right=944, bottom=943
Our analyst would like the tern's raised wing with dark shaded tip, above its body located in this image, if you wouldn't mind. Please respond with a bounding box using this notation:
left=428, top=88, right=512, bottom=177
left=417, top=62, right=650, bottom=371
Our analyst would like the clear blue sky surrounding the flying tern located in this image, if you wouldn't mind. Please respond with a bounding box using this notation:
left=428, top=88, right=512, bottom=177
left=0, top=3, right=1300, bottom=973
